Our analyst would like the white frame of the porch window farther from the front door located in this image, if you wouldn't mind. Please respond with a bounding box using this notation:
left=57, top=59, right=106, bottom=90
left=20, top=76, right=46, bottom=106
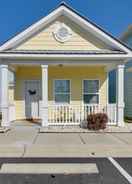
left=82, top=79, right=100, bottom=105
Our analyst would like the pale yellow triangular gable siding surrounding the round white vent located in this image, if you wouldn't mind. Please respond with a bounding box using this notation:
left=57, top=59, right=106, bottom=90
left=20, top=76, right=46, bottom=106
left=16, top=17, right=107, bottom=50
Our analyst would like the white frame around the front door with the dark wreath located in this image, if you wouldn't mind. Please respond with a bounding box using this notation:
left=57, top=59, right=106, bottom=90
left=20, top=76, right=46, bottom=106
left=23, top=79, right=42, bottom=119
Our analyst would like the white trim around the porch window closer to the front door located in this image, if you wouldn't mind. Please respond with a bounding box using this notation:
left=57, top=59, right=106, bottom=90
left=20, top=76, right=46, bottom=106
left=53, top=78, right=71, bottom=105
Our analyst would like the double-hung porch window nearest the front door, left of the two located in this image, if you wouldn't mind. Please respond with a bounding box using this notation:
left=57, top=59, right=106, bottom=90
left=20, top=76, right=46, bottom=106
left=54, top=80, right=70, bottom=103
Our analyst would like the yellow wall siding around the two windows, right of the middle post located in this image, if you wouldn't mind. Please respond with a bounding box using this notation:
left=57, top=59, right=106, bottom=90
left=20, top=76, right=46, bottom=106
left=49, top=67, right=107, bottom=104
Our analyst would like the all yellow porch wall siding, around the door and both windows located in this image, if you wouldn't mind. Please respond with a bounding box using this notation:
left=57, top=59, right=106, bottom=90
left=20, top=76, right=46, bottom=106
left=15, top=67, right=107, bottom=119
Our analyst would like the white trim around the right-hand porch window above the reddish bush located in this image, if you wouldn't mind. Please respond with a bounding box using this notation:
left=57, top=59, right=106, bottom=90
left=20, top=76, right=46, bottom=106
left=82, top=79, right=100, bottom=105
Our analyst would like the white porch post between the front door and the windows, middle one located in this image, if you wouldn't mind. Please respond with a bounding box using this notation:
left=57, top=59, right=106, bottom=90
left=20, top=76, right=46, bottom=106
left=41, top=65, right=48, bottom=127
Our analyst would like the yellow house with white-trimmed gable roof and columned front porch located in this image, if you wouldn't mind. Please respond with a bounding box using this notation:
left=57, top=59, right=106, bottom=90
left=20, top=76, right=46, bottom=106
left=0, top=3, right=132, bottom=127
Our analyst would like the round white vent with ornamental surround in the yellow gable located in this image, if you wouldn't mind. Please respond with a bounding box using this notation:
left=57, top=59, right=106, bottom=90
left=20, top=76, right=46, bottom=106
left=53, top=24, right=72, bottom=43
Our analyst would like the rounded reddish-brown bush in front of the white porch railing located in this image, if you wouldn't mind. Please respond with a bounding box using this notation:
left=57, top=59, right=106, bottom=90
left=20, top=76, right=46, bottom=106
left=87, top=113, right=108, bottom=130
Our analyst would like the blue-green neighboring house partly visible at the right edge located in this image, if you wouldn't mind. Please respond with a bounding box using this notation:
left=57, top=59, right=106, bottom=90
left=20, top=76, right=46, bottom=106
left=120, top=25, right=132, bottom=118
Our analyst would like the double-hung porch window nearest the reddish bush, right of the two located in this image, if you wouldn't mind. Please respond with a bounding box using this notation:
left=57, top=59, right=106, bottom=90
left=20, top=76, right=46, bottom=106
left=83, top=80, right=99, bottom=104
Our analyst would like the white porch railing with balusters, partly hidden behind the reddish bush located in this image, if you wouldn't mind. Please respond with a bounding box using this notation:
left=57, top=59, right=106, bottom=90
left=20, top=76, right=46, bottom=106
left=48, top=104, right=116, bottom=125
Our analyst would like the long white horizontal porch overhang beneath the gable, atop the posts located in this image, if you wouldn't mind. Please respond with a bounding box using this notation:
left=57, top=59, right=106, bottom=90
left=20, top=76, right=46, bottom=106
left=0, top=52, right=132, bottom=64
